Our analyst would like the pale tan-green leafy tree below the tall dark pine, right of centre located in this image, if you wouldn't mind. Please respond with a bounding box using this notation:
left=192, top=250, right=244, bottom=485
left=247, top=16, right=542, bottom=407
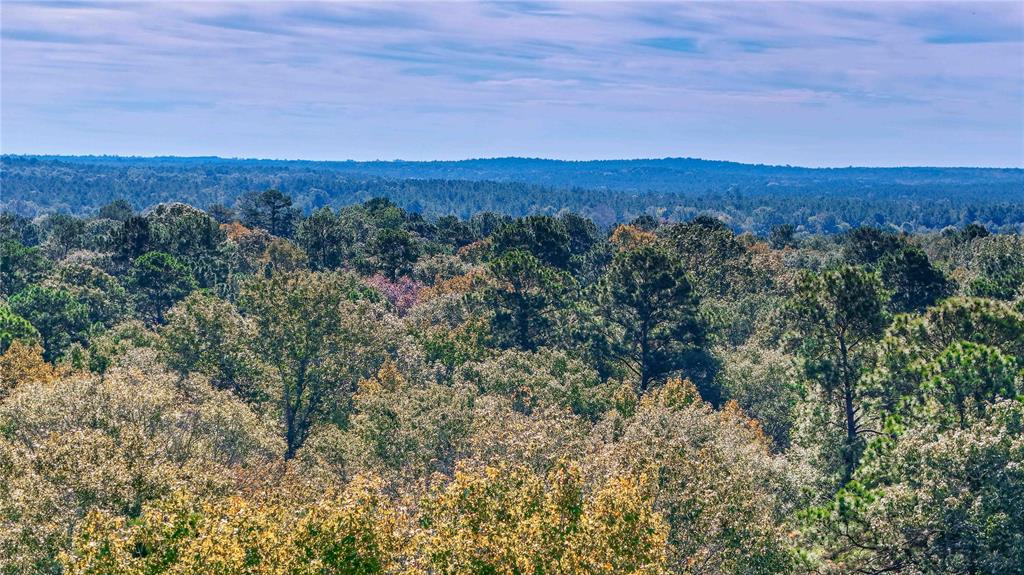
left=587, top=379, right=800, bottom=575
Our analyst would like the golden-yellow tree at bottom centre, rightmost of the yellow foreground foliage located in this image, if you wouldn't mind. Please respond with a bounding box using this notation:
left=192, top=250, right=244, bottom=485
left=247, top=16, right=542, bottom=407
left=420, top=465, right=668, bottom=575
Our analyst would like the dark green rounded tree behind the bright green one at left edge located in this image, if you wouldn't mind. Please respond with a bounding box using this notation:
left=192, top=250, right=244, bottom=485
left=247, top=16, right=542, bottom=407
left=10, top=285, right=89, bottom=361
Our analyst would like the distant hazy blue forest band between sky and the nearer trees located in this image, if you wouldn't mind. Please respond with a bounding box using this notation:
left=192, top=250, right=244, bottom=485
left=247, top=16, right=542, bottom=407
left=8, top=156, right=1024, bottom=235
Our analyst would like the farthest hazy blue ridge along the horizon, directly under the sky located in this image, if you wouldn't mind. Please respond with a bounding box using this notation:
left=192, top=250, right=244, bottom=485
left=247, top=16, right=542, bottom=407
left=12, top=156, right=1024, bottom=200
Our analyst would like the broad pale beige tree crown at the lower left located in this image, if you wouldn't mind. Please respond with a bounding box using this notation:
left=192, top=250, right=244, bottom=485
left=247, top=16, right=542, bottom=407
left=0, top=354, right=284, bottom=573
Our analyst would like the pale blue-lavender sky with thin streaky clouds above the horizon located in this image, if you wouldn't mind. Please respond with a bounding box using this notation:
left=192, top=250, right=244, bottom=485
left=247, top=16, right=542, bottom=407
left=0, top=0, right=1024, bottom=167
